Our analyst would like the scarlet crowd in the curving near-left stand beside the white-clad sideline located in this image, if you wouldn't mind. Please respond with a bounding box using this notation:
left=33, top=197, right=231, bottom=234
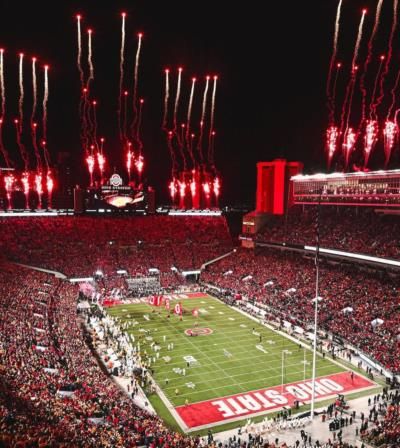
left=0, top=263, right=197, bottom=448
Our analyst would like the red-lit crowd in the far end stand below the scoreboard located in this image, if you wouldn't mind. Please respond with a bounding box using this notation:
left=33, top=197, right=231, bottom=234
left=0, top=216, right=232, bottom=281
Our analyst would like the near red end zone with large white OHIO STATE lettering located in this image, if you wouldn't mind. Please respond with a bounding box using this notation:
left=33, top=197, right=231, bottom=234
left=175, top=372, right=375, bottom=429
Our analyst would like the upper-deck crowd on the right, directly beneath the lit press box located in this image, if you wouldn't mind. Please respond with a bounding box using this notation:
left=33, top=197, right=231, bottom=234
left=257, top=206, right=400, bottom=258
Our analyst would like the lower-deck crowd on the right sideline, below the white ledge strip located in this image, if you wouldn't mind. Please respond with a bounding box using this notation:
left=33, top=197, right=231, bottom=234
left=201, top=249, right=400, bottom=373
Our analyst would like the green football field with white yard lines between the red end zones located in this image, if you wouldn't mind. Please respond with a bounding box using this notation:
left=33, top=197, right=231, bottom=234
left=107, top=296, right=344, bottom=407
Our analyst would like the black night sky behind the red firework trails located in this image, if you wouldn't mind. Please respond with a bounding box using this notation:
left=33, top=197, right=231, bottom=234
left=0, top=0, right=391, bottom=203
